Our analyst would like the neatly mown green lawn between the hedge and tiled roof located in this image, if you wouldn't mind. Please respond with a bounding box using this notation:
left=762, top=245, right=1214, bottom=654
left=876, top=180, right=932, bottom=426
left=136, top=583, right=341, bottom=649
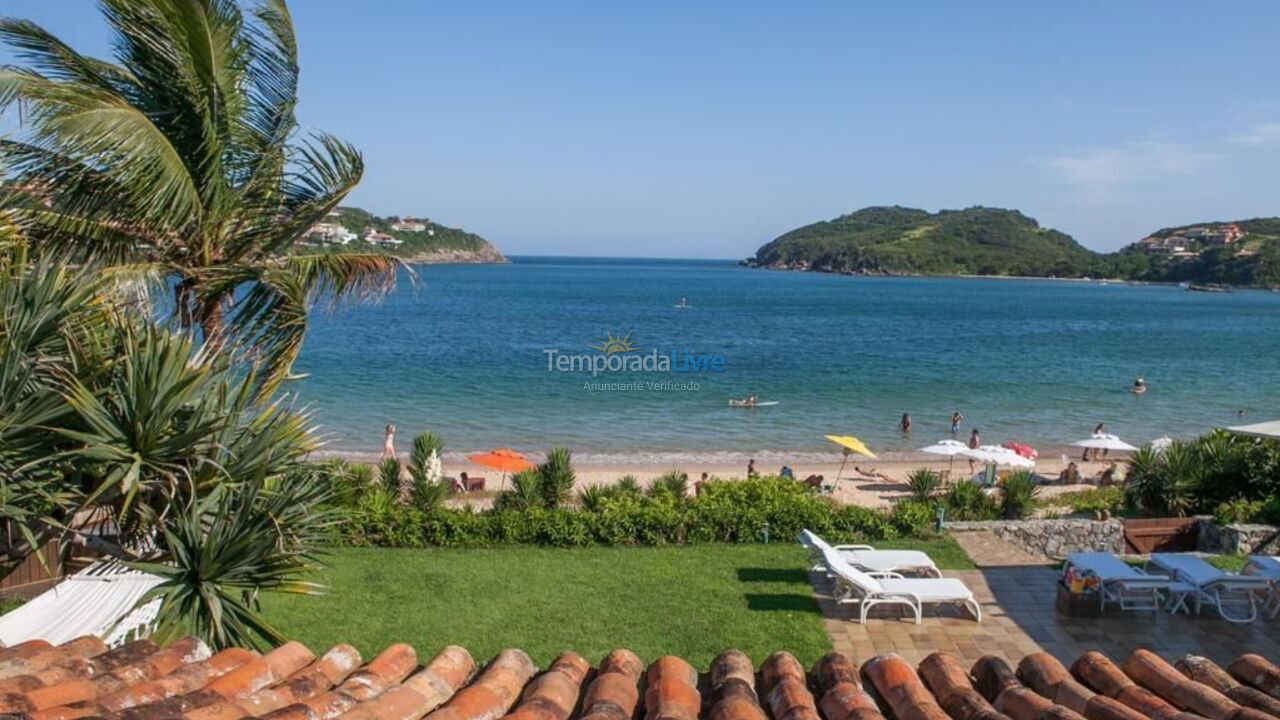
left=264, top=539, right=972, bottom=667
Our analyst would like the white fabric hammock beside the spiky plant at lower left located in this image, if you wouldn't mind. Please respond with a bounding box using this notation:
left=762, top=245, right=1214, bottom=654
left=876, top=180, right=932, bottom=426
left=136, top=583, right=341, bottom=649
left=0, top=560, right=161, bottom=647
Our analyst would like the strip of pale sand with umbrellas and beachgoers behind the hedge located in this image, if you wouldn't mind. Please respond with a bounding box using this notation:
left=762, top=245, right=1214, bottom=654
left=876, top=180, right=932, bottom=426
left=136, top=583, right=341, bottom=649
left=325, top=448, right=1125, bottom=507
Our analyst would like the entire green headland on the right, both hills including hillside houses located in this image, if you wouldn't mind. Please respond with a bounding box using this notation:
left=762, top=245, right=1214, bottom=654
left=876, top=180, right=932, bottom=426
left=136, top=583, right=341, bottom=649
left=742, top=206, right=1280, bottom=287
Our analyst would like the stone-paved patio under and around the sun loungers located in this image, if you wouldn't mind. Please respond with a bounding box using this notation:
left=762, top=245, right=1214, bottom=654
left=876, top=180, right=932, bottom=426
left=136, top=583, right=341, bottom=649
left=810, top=530, right=1280, bottom=664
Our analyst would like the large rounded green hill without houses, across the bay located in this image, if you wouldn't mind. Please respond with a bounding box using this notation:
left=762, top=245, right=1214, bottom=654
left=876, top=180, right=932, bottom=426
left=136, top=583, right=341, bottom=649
left=748, top=206, right=1107, bottom=277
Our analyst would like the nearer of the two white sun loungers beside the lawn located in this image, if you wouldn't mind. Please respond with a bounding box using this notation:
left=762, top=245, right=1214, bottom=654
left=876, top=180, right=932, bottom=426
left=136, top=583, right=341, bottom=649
left=823, top=550, right=982, bottom=625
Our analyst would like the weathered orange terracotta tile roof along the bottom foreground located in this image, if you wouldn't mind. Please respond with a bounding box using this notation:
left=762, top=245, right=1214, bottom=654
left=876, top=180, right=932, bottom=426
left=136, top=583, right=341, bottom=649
left=0, top=638, right=1280, bottom=720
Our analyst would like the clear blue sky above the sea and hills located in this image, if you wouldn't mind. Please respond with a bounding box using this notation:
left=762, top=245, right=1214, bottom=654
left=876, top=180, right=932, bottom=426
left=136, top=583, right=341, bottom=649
left=0, top=0, right=1280, bottom=258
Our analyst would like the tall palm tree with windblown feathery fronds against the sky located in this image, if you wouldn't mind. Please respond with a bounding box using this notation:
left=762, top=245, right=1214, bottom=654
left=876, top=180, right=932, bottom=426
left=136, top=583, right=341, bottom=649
left=0, top=0, right=401, bottom=393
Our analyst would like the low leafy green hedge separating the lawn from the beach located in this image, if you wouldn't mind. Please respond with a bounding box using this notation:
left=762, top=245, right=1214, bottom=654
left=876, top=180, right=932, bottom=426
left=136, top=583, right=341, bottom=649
left=342, top=478, right=932, bottom=547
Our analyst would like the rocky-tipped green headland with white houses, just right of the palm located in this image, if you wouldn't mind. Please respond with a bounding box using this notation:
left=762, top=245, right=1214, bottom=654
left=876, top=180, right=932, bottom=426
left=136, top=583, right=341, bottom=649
left=296, top=206, right=508, bottom=264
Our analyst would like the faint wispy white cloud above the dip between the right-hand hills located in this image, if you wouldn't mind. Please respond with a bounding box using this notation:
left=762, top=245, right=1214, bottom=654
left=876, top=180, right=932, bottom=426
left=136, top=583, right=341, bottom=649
left=1042, top=141, right=1219, bottom=195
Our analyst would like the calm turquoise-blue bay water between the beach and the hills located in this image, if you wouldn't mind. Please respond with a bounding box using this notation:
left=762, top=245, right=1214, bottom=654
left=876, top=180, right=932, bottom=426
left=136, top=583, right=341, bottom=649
left=294, top=258, right=1280, bottom=459
